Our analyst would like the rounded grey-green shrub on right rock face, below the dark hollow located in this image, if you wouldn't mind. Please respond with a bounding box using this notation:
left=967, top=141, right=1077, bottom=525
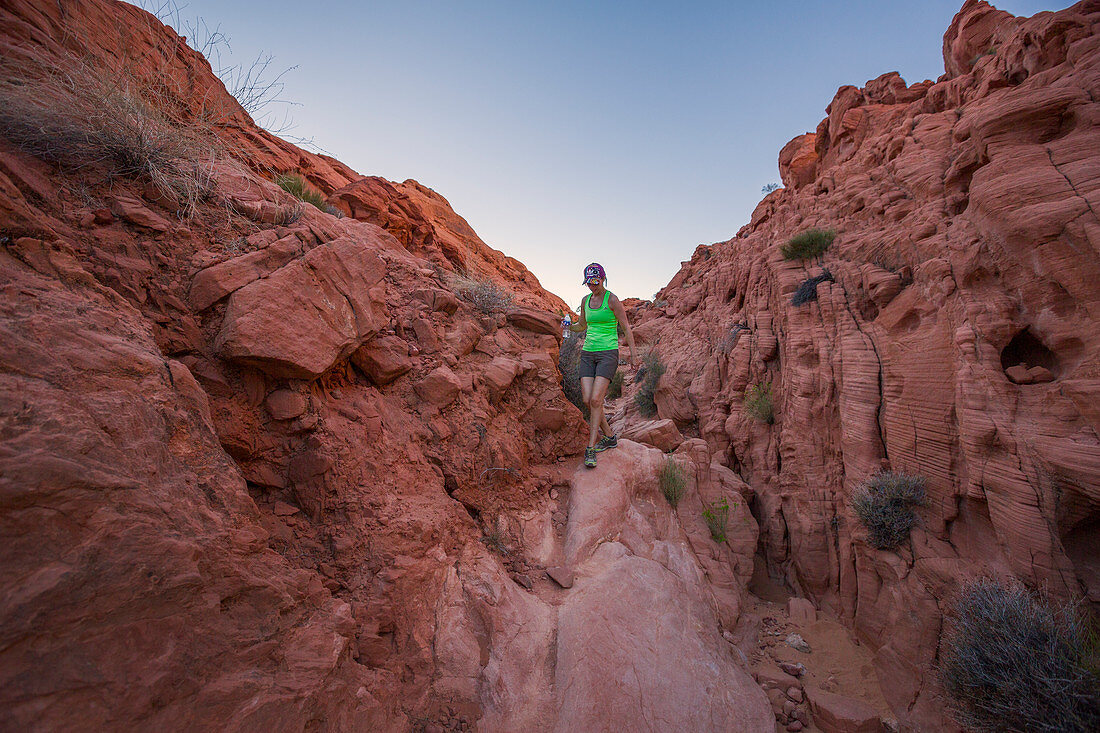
left=851, top=471, right=926, bottom=549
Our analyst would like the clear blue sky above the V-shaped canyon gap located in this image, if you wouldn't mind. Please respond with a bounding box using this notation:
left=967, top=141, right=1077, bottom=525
left=139, top=0, right=1069, bottom=304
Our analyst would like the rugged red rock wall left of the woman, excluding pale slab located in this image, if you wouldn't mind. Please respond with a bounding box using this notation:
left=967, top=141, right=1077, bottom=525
left=0, top=0, right=583, bottom=731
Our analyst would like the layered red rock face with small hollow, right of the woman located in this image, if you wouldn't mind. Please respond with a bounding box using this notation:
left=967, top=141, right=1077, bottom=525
left=626, top=0, right=1100, bottom=730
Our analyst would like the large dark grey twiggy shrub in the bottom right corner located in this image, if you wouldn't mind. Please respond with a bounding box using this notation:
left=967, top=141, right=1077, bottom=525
left=939, top=579, right=1100, bottom=733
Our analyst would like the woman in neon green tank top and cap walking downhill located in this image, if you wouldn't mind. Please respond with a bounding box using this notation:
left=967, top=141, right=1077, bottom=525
left=569, top=262, right=635, bottom=468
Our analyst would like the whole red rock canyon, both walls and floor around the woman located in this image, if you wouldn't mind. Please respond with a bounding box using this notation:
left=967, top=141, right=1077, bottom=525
left=0, top=0, right=1100, bottom=733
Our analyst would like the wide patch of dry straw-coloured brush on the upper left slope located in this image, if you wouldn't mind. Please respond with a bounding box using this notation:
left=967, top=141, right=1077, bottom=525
left=0, top=58, right=218, bottom=216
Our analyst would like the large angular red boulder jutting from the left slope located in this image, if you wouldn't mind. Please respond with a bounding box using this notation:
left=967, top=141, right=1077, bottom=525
left=215, top=239, right=385, bottom=379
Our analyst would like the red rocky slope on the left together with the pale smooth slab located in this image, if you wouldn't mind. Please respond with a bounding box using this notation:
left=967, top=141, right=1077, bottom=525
left=0, top=0, right=772, bottom=731
